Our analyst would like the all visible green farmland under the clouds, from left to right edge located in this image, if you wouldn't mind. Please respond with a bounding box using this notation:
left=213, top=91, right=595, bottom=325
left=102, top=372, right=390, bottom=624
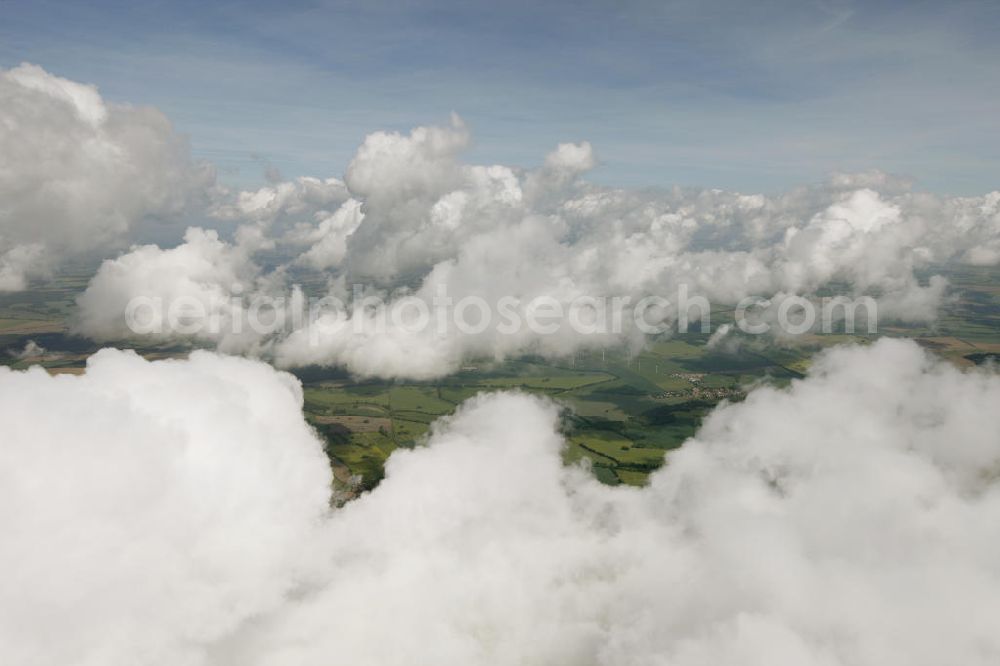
left=0, top=267, right=1000, bottom=490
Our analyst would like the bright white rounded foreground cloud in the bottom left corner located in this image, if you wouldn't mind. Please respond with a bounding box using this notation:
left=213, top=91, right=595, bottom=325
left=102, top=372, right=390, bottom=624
left=0, top=349, right=331, bottom=666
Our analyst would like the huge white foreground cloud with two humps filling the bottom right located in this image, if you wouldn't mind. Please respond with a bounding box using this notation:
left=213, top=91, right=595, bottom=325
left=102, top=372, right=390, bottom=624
left=234, top=341, right=1000, bottom=666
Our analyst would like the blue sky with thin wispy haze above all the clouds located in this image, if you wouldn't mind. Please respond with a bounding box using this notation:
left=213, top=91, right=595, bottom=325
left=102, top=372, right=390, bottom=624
left=0, top=0, right=1000, bottom=194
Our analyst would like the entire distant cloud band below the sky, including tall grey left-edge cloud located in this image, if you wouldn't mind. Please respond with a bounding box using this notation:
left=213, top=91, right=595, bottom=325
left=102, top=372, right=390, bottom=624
left=7, top=65, right=1000, bottom=378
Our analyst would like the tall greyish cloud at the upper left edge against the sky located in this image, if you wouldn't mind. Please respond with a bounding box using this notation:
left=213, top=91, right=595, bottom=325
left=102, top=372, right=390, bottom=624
left=0, top=64, right=214, bottom=291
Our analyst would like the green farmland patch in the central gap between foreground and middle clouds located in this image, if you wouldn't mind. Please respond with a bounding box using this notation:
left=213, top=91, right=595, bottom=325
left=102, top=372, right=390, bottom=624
left=301, top=336, right=828, bottom=488
